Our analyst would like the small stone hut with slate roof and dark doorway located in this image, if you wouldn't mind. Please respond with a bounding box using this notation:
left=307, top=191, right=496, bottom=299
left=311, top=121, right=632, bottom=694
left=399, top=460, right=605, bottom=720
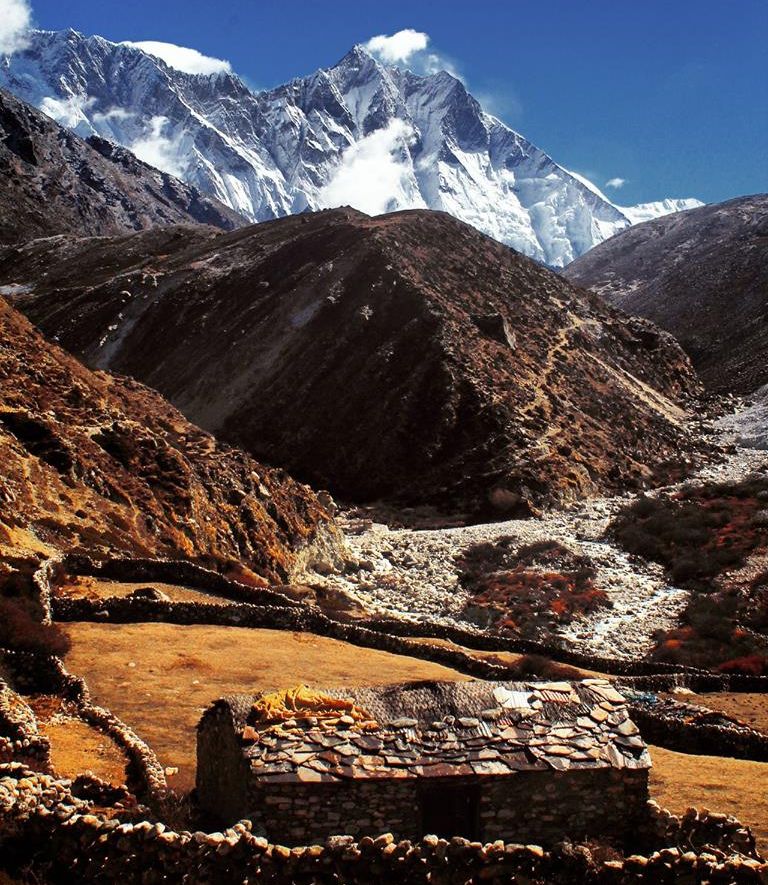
left=197, top=679, right=651, bottom=845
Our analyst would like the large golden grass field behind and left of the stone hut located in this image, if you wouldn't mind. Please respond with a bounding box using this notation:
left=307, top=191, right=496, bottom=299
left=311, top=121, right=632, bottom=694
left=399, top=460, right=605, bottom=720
left=66, top=623, right=468, bottom=790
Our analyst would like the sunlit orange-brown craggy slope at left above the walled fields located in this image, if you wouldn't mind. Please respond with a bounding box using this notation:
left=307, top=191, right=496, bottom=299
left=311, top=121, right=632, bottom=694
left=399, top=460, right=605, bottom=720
left=0, top=298, right=336, bottom=581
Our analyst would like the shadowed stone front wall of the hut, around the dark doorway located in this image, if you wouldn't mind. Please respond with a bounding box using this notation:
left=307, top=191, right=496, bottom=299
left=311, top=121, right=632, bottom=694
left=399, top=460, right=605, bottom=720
left=244, top=768, right=648, bottom=846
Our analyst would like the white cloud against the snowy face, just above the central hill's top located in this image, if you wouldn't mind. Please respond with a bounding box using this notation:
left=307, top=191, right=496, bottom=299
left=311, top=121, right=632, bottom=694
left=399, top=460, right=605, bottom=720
left=318, top=119, right=414, bottom=215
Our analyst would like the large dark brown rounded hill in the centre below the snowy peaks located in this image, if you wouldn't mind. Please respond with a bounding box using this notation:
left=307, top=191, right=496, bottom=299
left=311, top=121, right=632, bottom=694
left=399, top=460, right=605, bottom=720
left=0, top=209, right=697, bottom=513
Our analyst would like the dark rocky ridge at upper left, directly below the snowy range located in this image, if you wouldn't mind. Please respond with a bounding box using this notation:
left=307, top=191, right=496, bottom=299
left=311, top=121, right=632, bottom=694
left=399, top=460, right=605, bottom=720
left=0, top=89, right=245, bottom=243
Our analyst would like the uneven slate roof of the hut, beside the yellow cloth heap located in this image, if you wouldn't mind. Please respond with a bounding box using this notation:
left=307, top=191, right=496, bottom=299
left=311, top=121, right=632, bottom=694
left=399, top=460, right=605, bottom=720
left=207, top=679, right=651, bottom=783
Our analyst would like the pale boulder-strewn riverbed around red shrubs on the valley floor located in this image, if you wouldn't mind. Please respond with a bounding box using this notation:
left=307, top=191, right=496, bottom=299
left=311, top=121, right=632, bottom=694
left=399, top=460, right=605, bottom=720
left=317, top=438, right=768, bottom=658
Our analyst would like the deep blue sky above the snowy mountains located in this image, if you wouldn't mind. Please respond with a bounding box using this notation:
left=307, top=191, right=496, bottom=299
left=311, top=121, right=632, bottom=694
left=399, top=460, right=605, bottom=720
left=21, top=0, right=768, bottom=204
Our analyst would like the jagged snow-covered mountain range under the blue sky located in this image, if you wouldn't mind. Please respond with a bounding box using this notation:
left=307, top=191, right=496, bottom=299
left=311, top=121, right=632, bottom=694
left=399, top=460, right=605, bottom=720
left=0, top=30, right=699, bottom=267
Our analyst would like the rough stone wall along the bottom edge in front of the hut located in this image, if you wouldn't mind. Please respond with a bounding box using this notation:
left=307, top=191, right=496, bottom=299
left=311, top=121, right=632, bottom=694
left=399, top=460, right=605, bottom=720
left=0, top=765, right=768, bottom=885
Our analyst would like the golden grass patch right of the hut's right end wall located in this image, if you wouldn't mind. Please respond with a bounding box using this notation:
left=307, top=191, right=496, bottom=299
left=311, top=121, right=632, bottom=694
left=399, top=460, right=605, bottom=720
left=650, top=747, right=768, bottom=854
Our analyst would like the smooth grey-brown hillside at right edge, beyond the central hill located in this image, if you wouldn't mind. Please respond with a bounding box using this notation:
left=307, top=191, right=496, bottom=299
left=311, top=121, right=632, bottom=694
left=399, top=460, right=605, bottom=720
left=565, top=194, right=768, bottom=394
